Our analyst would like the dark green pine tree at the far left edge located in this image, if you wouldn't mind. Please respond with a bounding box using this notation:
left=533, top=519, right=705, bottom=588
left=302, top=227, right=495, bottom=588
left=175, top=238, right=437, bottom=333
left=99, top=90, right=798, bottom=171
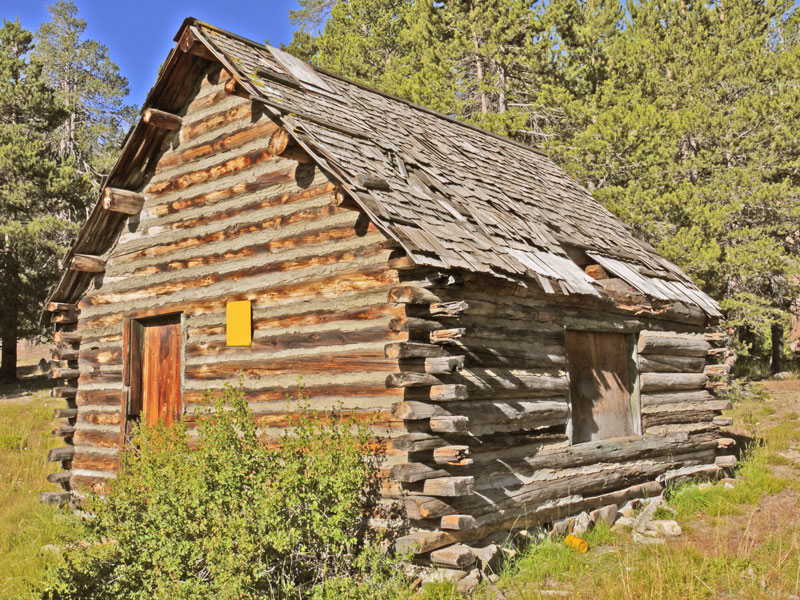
left=0, top=20, right=88, bottom=382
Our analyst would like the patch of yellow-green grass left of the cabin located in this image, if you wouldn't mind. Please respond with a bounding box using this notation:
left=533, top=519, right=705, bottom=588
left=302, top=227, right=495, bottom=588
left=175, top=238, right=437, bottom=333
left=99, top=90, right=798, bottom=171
left=0, top=382, right=82, bottom=600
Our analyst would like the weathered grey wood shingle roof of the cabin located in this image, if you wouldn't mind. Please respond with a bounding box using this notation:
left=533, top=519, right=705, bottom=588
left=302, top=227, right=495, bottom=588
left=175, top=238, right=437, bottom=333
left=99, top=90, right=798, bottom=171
left=42, top=19, right=720, bottom=317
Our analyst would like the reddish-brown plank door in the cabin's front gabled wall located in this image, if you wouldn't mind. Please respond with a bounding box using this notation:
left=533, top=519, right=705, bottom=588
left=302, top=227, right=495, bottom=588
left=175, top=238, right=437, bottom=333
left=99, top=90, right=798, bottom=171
left=126, top=315, right=183, bottom=432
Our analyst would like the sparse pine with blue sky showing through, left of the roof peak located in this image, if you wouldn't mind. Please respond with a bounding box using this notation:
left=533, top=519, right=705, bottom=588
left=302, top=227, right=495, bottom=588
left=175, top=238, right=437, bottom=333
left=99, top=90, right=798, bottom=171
left=34, top=0, right=136, bottom=186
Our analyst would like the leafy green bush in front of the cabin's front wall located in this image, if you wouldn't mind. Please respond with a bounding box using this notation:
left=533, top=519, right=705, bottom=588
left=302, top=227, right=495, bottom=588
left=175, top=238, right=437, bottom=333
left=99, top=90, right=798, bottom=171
left=44, top=386, right=404, bottom=600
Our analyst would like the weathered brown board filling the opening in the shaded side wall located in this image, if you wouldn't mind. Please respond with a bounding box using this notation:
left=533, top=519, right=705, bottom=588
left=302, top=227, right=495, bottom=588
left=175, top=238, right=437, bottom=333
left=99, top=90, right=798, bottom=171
left=567, top=331, right=638, bottom=444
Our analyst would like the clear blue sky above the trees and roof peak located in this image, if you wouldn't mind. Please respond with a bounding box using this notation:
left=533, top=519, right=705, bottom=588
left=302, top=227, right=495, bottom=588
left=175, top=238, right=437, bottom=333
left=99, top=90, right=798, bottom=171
left=0, top=0, right=297, bottom=106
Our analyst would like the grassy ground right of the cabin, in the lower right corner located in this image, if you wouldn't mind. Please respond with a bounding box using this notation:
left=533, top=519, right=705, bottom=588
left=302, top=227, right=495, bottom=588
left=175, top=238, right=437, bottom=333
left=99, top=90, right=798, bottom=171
left=462, top=380, right=800, bottom=600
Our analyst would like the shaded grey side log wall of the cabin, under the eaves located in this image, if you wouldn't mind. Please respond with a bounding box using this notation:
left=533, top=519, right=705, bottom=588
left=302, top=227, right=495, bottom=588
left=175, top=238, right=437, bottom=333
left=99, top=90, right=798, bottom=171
left=386, top=268, right=729, bottom=566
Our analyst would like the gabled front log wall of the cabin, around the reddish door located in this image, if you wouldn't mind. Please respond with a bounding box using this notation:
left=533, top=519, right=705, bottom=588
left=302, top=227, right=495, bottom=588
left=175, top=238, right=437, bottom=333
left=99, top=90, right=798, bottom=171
left=51, top=67, right=408, bottom=490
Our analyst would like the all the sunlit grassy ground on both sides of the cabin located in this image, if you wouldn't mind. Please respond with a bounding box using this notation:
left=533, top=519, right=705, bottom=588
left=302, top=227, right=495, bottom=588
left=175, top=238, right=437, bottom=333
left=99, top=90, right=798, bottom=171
left=0, top=382, right=800, bottom=600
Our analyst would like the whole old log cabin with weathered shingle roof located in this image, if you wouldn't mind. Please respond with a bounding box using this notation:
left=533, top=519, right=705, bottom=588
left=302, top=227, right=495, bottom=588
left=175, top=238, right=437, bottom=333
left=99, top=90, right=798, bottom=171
left=42, top=19, right=735, bottom=567
